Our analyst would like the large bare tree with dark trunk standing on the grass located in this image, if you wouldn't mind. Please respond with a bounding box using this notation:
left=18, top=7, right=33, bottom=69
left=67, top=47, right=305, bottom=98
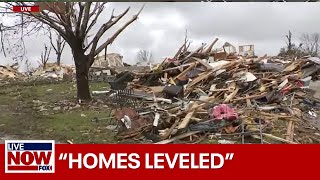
left=1, top=2, right=143, bottom=100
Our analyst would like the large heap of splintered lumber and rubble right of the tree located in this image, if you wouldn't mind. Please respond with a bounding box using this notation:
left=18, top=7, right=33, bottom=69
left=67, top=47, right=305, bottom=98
left=95, top=39, right=320, bottom=144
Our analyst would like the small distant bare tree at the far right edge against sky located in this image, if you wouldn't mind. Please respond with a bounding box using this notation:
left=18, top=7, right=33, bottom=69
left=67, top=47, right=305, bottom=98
left=300, top=33, right=320, bottom=56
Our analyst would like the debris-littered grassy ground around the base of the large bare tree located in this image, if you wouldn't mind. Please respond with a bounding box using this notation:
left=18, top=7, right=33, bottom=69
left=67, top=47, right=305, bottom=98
left=0, top=81, right=320, bottom=143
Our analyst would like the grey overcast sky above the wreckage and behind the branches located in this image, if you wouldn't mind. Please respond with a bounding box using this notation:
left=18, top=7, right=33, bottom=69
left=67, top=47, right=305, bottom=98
left=0, top=2, right=320, bottom=71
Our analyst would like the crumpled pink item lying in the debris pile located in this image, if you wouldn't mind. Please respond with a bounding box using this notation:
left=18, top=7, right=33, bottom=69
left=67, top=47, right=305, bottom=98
left=210, top=104, right=238, bottom=121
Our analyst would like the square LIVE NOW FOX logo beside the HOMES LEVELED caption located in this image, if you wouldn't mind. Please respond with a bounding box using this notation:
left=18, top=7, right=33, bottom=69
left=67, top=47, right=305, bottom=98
left=5, top=140, right=55, bottom=173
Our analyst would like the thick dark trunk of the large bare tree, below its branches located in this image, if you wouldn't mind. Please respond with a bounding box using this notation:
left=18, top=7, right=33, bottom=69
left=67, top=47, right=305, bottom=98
left=73, top=52, right=91, bottom=100
